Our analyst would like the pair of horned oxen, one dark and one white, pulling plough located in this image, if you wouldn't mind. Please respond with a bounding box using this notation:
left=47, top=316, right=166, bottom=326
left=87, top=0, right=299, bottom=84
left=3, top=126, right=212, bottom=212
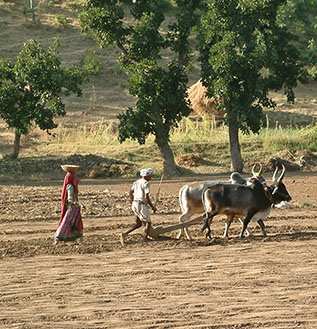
left=178, top=163, right=291, bottom=240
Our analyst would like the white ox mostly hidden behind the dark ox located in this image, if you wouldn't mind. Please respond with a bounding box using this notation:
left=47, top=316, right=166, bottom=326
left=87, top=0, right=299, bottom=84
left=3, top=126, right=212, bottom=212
left=177, top=163, right=266, bottom=240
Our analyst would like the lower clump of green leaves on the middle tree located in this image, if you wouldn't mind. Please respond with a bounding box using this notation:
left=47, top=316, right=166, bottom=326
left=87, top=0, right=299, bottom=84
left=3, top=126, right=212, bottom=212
left=119, top=61, right=189, bottom=144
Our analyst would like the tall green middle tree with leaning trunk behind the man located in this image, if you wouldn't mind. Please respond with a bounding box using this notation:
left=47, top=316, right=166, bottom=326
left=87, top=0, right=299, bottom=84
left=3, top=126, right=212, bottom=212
left=80, top=0, right=199, bottom=175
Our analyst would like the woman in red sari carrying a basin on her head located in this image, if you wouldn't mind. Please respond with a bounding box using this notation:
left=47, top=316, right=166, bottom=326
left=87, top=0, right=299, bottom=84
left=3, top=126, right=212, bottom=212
left=54, top=165, right=84, bottom=245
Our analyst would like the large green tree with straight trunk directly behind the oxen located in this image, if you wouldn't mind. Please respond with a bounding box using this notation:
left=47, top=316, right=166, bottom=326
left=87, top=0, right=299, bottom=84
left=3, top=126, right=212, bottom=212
left=199, top=0, right=303, bottom=172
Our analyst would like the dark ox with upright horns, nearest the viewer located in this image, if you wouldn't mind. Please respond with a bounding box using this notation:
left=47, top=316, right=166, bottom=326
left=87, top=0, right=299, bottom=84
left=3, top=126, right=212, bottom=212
left=202, top=166, right=292, bottom=239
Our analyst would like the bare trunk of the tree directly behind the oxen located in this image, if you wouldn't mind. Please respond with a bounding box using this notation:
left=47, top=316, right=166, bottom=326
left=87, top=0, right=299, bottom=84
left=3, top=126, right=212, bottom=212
left=227, top=107, right=243, bottom=173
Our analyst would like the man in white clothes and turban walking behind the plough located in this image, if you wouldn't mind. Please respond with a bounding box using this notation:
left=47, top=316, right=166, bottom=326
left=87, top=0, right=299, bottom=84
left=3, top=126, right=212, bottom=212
left=120, top=168, right=156, bottom=245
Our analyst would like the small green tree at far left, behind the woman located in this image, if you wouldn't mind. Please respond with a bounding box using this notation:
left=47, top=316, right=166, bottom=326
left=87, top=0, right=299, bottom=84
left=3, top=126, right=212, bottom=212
left=0, top=39, right=85, bottom=159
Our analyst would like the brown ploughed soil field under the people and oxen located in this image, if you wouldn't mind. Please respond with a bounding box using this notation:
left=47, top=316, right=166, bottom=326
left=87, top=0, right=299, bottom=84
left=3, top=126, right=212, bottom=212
left=0, top=173, right=317, bottom=329
